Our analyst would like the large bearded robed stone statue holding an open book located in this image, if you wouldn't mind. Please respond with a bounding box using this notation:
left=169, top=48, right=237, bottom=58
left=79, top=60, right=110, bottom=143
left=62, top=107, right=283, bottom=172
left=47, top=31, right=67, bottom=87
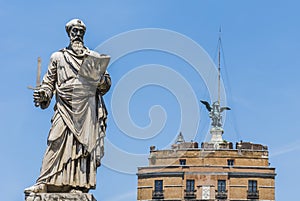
left=25, top=19, right=111, bottom=194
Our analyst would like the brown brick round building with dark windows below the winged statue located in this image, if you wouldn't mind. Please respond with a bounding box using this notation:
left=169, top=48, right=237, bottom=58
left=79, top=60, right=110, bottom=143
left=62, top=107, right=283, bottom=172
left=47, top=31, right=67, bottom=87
left=137, top=136, right=276, bottom=201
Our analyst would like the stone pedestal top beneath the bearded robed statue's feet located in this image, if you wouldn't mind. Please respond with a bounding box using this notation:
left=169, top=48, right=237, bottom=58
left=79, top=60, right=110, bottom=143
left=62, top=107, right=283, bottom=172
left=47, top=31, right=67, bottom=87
left=25, top=193, right=97, bottom=201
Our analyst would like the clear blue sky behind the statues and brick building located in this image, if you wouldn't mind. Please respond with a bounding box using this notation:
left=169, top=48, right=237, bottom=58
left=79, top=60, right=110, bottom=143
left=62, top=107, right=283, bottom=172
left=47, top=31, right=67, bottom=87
left=0, top=0, right=300, bottom=201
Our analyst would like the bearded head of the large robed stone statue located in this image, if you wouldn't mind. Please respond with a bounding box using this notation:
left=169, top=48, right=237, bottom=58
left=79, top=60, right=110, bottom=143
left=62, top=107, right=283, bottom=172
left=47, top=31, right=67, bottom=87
left=66, top=19, right=86, bottom=43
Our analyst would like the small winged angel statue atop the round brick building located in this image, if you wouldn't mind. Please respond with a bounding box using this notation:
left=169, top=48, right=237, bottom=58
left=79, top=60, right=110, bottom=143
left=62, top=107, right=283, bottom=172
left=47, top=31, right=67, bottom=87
left=200, top=100, right=230, bottom=128
